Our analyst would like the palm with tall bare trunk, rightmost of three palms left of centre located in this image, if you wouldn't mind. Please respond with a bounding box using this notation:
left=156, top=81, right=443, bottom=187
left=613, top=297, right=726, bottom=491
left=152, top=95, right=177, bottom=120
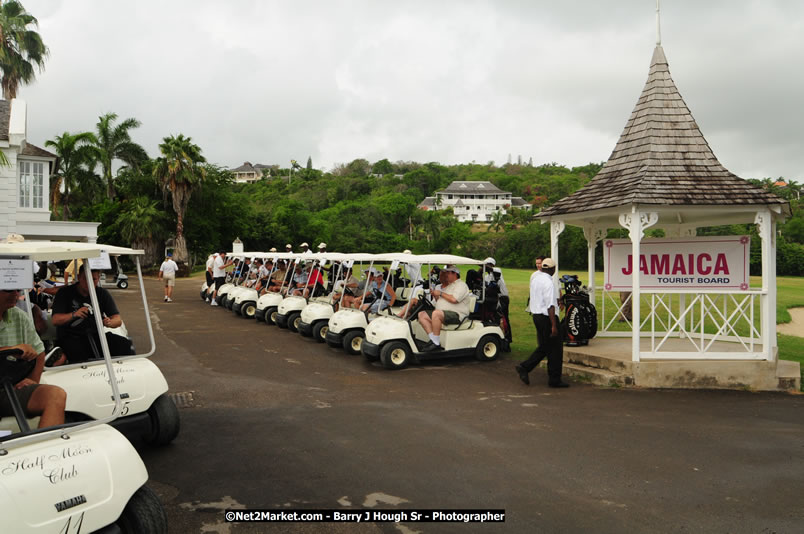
left=153, top=134, right=206, bottom=263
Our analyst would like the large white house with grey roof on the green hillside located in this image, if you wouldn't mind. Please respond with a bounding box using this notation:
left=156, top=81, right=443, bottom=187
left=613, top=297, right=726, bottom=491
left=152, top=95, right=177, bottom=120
left=419, top=182, right=532, bottom=222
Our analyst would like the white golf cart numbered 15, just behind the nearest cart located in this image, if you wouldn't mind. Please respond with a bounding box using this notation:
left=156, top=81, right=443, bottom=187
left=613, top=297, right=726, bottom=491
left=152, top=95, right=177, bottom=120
left=28, top=243, right=180, bottom=445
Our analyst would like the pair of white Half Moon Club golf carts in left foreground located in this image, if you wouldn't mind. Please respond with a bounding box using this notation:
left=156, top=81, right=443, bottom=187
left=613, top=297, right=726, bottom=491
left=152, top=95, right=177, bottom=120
left=0, top=242, right=179, bottom=534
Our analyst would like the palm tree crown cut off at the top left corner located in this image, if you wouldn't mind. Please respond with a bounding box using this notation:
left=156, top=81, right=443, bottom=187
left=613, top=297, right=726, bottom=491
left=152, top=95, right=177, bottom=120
left=0, top=0, right=48, bottom=100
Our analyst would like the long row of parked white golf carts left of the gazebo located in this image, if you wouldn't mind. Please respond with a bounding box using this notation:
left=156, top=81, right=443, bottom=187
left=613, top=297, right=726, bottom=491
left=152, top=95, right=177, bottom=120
left=201, top=252, right=510, bottom=370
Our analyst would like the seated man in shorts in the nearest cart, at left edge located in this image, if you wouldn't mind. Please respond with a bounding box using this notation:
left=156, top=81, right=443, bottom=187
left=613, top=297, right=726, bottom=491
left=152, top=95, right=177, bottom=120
left=0, top=289, right=67, bottom=428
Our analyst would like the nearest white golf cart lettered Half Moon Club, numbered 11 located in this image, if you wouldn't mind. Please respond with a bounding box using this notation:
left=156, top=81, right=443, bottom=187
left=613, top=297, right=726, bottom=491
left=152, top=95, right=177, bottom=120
left=0, top=243, right=167, bottom=534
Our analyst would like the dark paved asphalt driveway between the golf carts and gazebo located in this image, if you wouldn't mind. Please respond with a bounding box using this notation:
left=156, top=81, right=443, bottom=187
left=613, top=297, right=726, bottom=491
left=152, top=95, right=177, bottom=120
left=114, top=279, right=804, bottom=533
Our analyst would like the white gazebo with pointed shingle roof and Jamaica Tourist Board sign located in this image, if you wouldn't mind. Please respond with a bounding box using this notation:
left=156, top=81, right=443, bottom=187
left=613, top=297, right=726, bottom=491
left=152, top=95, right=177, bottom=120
left=537, top=39, right=800, bottom=389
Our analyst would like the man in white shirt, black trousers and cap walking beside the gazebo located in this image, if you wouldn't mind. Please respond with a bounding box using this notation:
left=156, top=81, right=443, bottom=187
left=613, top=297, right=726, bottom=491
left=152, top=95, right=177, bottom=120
left=516, top=258, right=569, bottom=388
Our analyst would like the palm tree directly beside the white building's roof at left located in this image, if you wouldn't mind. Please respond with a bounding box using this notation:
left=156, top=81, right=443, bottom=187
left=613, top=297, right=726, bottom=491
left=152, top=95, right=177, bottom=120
left=45, top=132, right=95, bottom=221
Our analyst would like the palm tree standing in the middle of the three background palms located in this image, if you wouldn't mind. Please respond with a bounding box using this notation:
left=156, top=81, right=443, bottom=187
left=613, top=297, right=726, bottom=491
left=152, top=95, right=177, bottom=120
left=92, top=113, right=148, bottom=200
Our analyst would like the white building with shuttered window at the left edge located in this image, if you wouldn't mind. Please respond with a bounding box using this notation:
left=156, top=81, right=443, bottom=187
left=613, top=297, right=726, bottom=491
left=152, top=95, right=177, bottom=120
left=0, top=99, right=100, bottom=243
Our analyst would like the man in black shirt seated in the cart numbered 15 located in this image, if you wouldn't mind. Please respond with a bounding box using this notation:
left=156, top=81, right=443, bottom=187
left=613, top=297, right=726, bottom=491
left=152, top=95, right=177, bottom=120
left=53, top=266, right=134, bottom=365
